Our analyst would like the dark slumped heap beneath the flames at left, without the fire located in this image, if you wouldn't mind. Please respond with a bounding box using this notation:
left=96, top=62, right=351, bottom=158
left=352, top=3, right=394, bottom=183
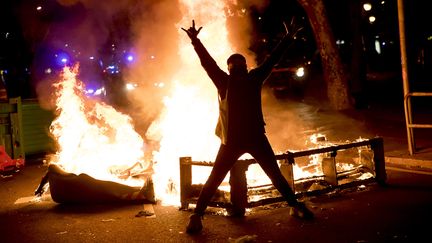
left=35, top=164, right=155, bottom=203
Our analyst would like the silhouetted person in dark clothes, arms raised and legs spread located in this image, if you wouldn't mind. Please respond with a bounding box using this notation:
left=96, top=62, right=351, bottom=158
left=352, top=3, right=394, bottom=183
left=182, top=21, right=313, bottom=233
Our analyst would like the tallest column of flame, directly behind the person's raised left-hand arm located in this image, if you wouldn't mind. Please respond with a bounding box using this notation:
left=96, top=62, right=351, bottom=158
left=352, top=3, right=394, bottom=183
left=146, top=0, right=240, bottom=205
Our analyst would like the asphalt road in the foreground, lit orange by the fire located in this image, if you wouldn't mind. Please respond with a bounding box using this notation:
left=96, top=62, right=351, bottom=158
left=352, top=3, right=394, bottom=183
left=0, top=164, right=432, bottom=242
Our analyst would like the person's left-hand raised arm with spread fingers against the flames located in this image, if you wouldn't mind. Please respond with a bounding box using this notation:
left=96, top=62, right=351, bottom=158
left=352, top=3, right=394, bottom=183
left=182, top=20, right=228, bottom=89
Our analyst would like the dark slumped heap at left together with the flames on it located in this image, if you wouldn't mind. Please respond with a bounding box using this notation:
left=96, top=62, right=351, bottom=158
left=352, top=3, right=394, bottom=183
left=35, top=67, right=155, bottom=203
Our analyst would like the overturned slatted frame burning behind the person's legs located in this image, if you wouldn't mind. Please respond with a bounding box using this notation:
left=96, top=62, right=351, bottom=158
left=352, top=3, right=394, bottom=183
left=180, top=138, right=386, bottom=212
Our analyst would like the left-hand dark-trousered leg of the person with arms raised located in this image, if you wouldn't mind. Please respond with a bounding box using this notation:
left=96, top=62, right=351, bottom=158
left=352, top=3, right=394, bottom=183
left=186, top=145, right=239, bottom=234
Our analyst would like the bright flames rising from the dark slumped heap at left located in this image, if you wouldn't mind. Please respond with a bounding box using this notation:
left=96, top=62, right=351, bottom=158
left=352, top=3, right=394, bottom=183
left=50, top=66, right=144, bottom=185
